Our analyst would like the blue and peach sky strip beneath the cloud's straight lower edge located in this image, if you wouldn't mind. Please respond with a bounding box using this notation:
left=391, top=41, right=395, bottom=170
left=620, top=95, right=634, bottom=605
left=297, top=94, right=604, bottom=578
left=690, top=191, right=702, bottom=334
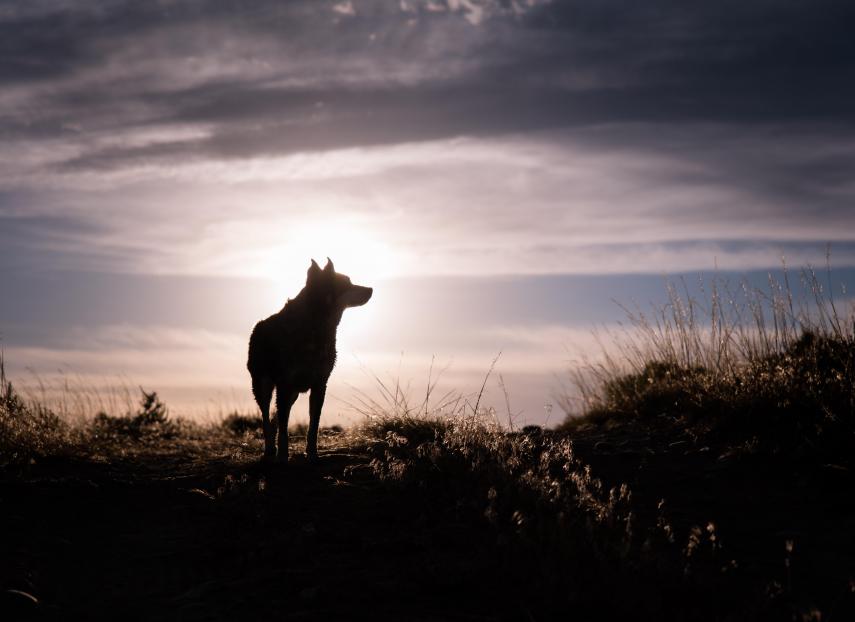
left=0, top=267, right=855, bottom=427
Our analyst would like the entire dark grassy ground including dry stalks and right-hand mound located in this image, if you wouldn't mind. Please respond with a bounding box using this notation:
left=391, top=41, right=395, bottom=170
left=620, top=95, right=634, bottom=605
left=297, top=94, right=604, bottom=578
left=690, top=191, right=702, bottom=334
left=0, top=271, right=855, bottom=620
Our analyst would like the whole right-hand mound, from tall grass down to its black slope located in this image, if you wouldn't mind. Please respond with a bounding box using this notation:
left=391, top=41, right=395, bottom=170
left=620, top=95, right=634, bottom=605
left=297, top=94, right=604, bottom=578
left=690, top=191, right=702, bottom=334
left=559, top=270, right=855, bottom=619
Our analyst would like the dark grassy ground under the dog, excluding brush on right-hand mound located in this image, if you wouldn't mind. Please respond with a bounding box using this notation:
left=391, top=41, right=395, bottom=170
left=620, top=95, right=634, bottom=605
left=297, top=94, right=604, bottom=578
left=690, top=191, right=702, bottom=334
left=0, top=356, right=855, bottom=620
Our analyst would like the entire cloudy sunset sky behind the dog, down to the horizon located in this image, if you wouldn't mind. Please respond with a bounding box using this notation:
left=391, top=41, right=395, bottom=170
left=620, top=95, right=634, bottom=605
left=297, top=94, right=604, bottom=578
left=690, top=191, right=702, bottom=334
left=0, top=0, right=855, bottom=423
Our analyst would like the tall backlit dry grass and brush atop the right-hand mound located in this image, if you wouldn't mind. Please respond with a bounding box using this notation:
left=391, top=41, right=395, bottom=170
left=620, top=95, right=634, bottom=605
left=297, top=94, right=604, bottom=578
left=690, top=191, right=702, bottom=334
left=559, top=268, right=855, bottom=451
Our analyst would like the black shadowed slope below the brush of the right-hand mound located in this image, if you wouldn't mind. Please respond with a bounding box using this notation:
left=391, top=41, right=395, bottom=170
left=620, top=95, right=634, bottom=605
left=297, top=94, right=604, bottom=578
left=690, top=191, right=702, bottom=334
left=575, top=424, right=855, bottom=622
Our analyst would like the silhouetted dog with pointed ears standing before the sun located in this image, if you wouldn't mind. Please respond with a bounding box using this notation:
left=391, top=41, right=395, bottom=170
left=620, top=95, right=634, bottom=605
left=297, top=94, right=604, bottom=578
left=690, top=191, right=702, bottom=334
left=247, top=257, right=374, bottom=462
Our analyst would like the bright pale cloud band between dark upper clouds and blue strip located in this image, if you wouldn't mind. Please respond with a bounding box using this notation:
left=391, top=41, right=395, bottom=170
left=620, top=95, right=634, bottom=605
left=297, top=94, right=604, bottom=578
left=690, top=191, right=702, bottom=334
left=5, top=124, right=855, bottom=276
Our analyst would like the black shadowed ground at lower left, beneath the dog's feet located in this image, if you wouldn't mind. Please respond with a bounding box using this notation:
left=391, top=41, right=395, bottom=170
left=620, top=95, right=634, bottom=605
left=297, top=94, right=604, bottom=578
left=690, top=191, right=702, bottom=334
left=0, top=438, right=524, bottom=620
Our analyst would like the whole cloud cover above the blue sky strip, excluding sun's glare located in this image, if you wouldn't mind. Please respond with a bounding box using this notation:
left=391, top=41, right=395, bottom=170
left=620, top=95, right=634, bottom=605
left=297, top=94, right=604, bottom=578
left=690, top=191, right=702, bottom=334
left=0, top=0, right=855, bottom=286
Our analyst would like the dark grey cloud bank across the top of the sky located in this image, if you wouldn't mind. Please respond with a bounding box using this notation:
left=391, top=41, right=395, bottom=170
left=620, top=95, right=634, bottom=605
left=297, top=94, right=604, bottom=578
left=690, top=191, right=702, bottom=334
left=0, top=0, right=855, bottom=162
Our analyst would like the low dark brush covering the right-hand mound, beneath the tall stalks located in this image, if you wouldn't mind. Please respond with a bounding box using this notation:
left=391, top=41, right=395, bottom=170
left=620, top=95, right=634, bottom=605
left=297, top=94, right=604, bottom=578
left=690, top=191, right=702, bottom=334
left=565, top=332, right=855, bottom=457
